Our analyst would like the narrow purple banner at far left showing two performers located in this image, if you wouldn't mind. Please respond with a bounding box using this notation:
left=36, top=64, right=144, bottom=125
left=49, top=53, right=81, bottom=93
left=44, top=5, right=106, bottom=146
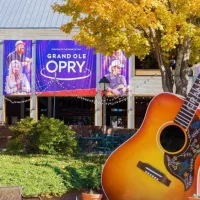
left=3, top=40, right=32, bottom=95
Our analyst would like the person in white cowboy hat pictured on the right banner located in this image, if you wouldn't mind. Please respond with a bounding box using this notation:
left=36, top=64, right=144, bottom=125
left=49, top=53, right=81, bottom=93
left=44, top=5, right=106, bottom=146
left=105, top=60, right=128, bottom=95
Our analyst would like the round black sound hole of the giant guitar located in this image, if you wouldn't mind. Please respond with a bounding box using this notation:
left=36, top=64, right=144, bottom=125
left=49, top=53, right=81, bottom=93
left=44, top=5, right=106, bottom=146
left=160, top=125, right=185, bottom=153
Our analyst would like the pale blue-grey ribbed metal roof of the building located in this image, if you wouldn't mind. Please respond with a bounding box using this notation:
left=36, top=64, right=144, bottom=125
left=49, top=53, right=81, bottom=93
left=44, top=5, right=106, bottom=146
left=0, top=0, right=71, bottom=29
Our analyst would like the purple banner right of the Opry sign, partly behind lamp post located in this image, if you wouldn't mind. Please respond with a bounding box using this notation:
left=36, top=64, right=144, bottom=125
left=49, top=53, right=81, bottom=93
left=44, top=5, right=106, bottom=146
left=101, top=50, right=129, bottom=96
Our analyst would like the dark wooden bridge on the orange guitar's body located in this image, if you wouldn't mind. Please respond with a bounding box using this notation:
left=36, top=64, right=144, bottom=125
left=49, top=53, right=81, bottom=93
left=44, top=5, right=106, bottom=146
left=137, top=161, right=171, bottom=187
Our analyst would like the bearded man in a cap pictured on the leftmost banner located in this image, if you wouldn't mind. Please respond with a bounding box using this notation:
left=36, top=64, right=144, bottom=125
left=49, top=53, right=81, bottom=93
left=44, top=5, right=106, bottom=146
left=7, top=40, right=32, bottom=80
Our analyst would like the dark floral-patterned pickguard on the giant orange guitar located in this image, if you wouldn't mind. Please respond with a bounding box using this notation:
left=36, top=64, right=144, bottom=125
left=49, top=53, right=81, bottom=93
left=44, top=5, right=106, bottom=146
left=164, top=115, right=200, bottom=190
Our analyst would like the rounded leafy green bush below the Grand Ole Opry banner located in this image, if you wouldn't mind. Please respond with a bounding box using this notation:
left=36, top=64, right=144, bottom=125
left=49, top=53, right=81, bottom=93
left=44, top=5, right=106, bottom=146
left=7, top=116, right=77, bottom=154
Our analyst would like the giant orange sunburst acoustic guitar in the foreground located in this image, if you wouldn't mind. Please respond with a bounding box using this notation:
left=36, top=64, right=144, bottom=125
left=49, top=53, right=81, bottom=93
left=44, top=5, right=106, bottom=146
left=102, top=75, right=200, bottom=200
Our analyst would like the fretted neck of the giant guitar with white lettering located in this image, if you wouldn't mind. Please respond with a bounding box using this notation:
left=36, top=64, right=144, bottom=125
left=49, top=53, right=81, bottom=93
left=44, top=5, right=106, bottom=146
left=174, top=74, right=200, bottom=129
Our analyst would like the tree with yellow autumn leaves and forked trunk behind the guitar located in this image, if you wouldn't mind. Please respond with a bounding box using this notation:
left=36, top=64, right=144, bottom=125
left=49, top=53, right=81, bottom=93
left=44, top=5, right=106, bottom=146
left=52, top=0, right=200, bottom=96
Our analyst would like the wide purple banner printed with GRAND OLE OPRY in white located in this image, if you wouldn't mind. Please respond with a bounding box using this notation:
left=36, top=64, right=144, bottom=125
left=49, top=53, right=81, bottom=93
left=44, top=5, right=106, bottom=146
left=36, top=40, right=96, bottom=95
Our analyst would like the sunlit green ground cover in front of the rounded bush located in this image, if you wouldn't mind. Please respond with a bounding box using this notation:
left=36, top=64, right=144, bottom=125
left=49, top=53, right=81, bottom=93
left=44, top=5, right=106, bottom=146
left=0, top=154, right=107, bottom=197
